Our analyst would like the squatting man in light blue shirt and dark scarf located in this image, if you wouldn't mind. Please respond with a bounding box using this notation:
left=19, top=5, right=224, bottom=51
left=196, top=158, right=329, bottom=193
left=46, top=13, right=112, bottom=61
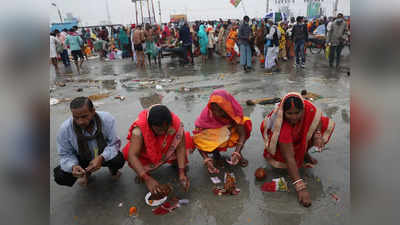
left=54, top=97, right=125, bottom=186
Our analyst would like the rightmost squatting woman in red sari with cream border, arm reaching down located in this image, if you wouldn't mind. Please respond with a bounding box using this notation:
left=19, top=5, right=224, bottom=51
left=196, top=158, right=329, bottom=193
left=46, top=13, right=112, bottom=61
left=261, top=93, right=335, bottom=207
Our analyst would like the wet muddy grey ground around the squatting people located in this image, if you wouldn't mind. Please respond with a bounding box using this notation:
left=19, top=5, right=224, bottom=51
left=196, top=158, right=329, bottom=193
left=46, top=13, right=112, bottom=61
left=50, top=51, right=350, bottom=225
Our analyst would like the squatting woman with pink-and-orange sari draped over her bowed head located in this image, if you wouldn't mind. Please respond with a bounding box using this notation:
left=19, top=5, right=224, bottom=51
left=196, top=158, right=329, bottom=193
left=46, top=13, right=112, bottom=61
left=193, top=89, right=251, bottom=174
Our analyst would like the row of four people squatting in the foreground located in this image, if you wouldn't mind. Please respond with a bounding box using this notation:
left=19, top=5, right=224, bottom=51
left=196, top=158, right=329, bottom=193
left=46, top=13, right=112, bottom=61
left=54, top=89, right=335, bottom=207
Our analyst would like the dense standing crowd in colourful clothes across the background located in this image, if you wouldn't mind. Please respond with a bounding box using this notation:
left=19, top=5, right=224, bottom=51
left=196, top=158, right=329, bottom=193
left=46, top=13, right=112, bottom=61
left=50, top=13, right=350, bottom=73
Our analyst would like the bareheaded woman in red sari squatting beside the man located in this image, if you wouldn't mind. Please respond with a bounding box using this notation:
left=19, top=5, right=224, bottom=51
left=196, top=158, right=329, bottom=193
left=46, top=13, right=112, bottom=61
left=123, top=105, right=193, bottom=194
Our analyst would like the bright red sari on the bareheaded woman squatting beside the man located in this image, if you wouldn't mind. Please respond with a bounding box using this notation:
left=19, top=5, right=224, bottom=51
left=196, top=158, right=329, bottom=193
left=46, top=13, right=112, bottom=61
left=122, top=109, right=194, bottom=172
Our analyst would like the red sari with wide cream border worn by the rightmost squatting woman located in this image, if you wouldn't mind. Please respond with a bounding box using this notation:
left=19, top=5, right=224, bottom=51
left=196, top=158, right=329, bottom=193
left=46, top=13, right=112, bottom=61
left=260, top=93, right=335, bottom=168
